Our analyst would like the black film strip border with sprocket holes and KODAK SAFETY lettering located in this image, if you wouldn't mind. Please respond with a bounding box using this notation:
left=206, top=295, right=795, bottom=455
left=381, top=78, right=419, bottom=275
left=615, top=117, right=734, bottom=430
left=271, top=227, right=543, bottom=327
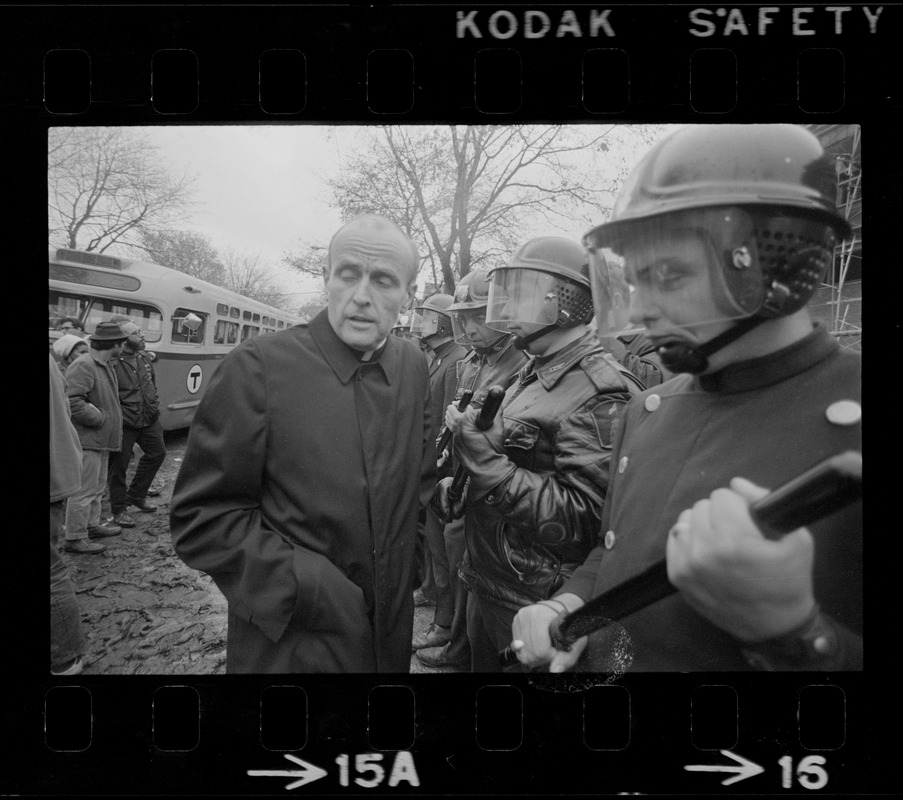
left=10, top=3, right=903, bottom=796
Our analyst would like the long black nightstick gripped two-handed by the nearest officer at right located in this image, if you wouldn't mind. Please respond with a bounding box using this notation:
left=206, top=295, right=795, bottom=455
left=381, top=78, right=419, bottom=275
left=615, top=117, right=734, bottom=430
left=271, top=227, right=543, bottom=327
left=499, top=451, right=862, bottom=667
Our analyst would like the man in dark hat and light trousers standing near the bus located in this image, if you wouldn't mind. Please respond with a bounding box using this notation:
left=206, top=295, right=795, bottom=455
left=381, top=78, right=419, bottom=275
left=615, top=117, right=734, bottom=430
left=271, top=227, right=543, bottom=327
left=63, top=322, right=126, bottom=553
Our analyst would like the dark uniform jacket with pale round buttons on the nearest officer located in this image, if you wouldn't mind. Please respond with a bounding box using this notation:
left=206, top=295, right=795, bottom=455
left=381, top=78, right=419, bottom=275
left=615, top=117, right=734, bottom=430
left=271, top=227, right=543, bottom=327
left=562, top=328, right=862, bottom=671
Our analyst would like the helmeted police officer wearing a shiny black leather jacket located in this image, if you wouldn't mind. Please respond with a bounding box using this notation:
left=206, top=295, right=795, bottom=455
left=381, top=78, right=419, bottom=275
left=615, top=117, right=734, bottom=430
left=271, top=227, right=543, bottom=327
left=440, top=236, right=636, bottom=672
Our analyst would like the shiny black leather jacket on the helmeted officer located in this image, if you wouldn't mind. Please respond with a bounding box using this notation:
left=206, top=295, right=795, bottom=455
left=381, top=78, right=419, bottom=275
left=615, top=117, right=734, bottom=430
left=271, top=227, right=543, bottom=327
left=455, top=333, right=638, bottom=609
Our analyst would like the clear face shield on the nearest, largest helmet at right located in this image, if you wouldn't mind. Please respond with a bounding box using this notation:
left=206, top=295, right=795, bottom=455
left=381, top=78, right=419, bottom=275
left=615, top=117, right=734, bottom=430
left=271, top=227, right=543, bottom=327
left=584, top=209, right=765, bottom=342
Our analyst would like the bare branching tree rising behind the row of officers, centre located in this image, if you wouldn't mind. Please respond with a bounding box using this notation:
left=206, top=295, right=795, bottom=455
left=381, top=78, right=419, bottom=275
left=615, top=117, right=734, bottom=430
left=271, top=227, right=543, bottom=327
left=328, top=125, right=655, bottom=292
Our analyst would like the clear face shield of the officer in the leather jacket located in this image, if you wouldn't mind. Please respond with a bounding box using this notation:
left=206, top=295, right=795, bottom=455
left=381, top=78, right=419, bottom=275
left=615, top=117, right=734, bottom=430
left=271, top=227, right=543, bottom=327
left=486, top=269, right=561, bottom=336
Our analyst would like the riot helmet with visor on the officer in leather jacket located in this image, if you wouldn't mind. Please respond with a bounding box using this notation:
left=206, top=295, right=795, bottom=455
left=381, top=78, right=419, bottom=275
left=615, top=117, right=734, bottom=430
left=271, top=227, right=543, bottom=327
left=486, top=236, right=593, bottom=347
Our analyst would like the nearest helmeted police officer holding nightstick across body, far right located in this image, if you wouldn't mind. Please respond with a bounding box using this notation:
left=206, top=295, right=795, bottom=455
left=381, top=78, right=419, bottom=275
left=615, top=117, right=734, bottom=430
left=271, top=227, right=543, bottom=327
left=512, top=125, right=862, bottom=672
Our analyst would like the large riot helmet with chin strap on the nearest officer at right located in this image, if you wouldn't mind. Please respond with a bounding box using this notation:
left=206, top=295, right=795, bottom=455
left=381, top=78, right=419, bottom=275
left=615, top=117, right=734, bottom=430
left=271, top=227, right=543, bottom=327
left=584, top=125, right=850, bottom=372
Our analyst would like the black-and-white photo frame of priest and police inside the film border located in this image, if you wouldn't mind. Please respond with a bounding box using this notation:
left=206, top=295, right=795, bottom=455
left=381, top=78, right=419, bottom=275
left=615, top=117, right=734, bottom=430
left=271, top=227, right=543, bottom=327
left=48, top=124, right=862, bottom=674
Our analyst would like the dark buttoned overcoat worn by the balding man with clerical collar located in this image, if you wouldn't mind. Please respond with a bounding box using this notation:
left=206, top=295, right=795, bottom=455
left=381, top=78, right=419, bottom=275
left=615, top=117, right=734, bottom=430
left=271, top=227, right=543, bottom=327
left=171, top=311, right=436, bottom=672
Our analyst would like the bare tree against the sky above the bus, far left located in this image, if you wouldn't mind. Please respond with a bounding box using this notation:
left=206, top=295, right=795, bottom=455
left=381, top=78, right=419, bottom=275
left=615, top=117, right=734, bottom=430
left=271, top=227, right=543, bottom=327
left=47, top=128, right=193, bottom=252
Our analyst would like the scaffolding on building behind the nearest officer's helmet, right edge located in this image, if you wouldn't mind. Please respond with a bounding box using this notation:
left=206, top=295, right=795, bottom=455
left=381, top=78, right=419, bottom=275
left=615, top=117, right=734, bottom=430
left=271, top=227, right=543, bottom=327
left=810, top=125, right=862, bottom=350
